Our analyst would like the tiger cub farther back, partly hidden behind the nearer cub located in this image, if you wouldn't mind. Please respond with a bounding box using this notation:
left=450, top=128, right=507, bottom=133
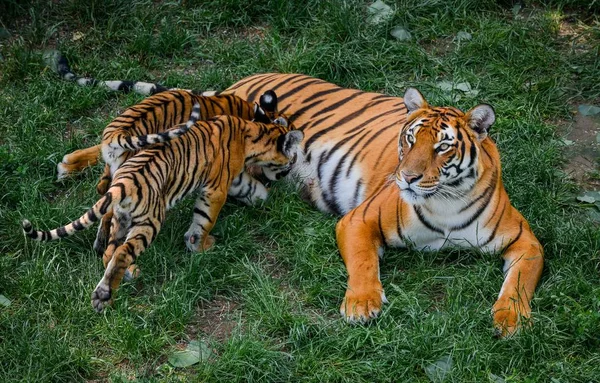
left=58, top=90, right=286, bottom=255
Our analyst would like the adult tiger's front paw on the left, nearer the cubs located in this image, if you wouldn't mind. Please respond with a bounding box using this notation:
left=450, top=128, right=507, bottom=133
left=340, top=288, right=387, bottom=323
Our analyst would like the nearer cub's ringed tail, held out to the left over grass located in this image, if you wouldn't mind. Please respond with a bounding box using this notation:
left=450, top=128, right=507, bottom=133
left=21, top=187, right=124, bottom=241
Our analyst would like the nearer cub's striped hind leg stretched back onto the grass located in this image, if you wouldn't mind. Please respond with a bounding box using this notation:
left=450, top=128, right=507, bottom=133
left=92, top=218, right=161, bottom=312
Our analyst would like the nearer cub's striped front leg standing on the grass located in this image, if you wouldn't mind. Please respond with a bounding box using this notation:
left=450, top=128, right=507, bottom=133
left=184, top=190, right=227, bottom=251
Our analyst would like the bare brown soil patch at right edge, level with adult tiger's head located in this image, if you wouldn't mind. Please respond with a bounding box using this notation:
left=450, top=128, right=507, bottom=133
left=565, top=113, right=600, bottom=190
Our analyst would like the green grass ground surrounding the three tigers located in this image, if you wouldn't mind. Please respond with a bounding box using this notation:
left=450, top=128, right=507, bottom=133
left=0, top=0, right=600, bottom=382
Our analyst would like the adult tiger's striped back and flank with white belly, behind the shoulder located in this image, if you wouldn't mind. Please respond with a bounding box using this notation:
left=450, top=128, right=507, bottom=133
left=221, top=73, right=407, bottom=215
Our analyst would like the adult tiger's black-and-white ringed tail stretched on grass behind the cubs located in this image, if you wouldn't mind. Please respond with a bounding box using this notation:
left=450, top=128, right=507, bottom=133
left=51, top=52, right=218, bottom=96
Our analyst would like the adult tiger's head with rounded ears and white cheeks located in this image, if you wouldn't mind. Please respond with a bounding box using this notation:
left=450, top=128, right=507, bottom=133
left=395, top=88, right=496, bottom=204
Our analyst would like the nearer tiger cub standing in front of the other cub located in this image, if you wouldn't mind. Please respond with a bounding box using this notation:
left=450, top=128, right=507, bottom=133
left=22, top=105, right=303, bottom=312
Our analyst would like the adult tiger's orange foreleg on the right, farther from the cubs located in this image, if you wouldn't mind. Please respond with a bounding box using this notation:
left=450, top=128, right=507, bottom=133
left=492, top=230, right=544, bottom=337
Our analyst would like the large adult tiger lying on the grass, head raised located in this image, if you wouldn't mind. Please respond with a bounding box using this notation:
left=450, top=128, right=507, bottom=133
left=55, top=56, right=543, bottom=335
